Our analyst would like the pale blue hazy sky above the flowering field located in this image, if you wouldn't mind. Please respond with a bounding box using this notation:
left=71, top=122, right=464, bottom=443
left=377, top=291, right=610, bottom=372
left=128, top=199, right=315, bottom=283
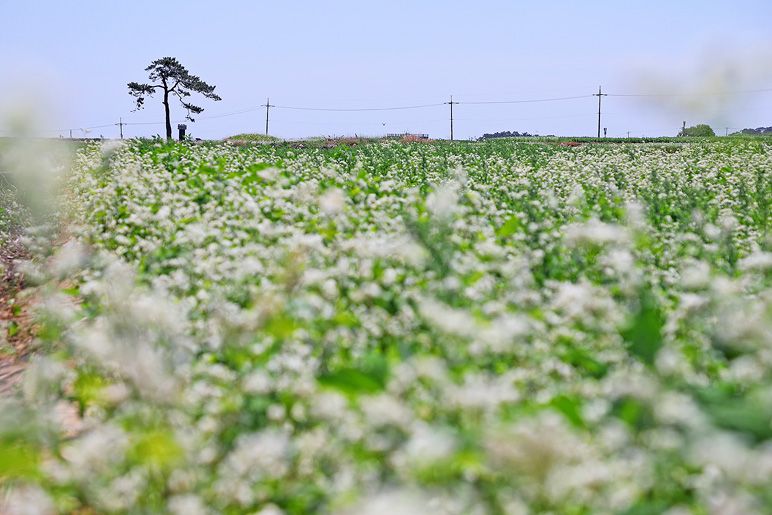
left=0, top=0, right=772, bottom=139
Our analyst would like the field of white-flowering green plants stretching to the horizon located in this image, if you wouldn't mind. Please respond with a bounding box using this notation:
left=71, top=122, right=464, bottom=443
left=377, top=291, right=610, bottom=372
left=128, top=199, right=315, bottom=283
left=0, top=140, right=772, bottom=515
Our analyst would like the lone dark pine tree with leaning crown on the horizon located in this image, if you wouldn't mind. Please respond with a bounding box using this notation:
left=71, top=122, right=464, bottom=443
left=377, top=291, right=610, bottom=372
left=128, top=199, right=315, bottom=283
left=128, top=57, right=222, bottom=139
